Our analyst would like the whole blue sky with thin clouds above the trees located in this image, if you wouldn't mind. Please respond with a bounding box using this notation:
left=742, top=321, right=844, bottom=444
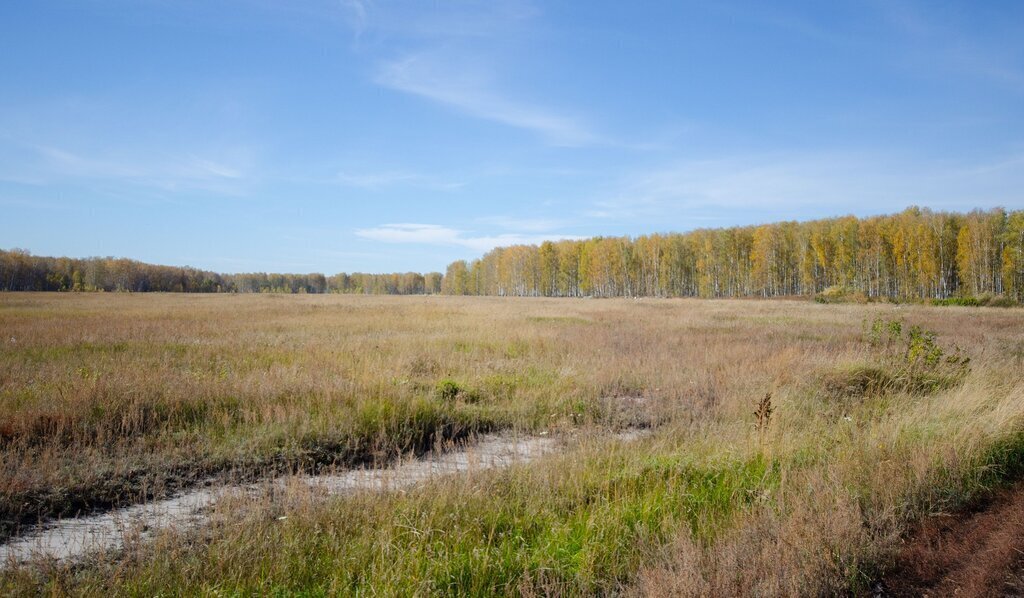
left=0, top=0, right=1024, bottom=273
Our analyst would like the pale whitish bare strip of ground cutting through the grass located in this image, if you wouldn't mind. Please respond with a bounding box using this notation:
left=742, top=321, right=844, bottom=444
left=0, top=430, right=642, bottom=568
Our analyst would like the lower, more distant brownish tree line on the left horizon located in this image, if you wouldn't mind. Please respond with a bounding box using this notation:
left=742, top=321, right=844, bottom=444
left=0, top=249, right=441, bottom=295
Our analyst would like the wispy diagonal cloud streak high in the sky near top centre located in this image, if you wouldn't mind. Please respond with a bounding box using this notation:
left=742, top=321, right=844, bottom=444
left=375, top=52, right=601, bottom=146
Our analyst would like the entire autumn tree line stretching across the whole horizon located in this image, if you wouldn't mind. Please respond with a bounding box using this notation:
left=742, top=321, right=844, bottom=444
left=0, top=208, right=1024, bottom=301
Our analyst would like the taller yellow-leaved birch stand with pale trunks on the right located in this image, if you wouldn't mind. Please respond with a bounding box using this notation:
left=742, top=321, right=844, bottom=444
left=442, top=208, right=1024, bottom=301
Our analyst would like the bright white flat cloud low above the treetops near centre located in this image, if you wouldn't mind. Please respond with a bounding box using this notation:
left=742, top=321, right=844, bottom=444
left=355, top=223, right=581, bottom=253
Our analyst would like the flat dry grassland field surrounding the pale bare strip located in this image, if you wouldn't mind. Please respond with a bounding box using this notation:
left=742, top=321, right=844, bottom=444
left=0, top=294, right=1024, bottom=595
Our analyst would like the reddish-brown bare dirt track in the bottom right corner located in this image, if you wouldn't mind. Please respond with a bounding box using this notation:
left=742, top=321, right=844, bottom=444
left=879, top=482, right=1024, bottom=597
